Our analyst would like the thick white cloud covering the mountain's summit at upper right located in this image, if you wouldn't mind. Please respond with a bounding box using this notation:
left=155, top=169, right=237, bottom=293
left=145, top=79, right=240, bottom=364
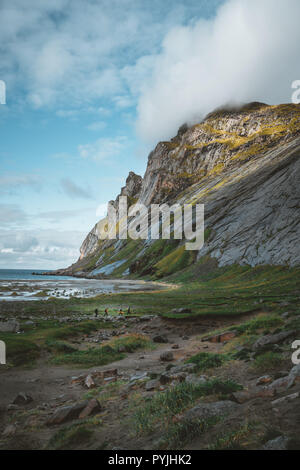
left=136, top=0, right=300, bottom=143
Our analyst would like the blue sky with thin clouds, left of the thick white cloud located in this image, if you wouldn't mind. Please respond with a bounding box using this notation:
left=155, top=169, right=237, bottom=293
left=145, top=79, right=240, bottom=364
left=0, top=0, right=220, bottom=269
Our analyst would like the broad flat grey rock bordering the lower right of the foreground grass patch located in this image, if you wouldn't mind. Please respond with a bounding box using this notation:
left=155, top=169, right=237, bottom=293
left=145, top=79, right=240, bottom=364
left=180, top=400, right=239, bottom=421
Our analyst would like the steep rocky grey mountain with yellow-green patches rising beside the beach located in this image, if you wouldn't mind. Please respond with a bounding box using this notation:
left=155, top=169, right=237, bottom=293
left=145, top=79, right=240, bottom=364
left=57, top=103, right=300, bottom=278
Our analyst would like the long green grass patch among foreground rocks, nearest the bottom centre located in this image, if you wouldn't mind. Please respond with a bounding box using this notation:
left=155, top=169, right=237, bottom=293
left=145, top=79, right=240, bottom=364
left=133, top=379, right=242, bottom=434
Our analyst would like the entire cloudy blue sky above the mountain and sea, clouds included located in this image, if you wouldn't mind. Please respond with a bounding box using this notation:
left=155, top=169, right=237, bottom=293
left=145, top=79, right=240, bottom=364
left=0, top=0, right=300, bottom=269
